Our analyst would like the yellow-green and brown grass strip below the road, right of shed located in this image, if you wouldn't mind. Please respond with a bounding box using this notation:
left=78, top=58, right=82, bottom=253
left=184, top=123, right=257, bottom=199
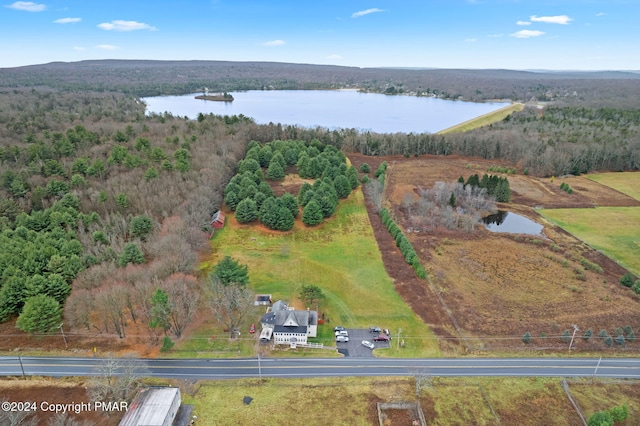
left=188, top=377, right=640, bottom=425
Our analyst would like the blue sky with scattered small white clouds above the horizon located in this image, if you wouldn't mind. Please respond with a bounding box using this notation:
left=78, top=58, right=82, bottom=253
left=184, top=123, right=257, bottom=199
left=0, top=0, right=640, bottom=70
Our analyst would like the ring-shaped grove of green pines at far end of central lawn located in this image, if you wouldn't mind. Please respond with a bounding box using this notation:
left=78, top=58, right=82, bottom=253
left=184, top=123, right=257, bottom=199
left=224, top=139, right=359, bottom=231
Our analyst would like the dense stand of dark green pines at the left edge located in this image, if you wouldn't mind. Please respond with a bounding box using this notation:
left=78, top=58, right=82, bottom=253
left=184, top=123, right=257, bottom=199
left=0, top=194, right=85, bottom=332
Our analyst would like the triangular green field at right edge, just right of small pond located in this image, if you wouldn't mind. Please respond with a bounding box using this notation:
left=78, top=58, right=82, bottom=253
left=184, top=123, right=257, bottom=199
left=538, top=207, right=640, bottom=275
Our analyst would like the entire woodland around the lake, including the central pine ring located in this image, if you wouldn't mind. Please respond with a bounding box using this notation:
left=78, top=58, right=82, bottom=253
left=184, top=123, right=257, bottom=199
left=0, top=61, right=640, bottom=339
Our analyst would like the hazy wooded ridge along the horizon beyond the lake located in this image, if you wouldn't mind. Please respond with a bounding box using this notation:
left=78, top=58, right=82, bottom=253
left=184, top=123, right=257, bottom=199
left=0, top=60, right=640, bottom=108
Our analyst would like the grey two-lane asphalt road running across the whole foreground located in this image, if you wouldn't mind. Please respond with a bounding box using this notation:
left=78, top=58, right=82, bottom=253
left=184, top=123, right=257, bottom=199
left=0, top=357, right=640, bottom=379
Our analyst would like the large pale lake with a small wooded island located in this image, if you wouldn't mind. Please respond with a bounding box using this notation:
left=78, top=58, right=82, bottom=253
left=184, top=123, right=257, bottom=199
left=143, top=90, right=509, bottom=133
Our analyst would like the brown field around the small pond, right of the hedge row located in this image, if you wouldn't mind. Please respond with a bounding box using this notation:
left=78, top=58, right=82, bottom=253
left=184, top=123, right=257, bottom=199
left=350, top=155, right=640, bottom=352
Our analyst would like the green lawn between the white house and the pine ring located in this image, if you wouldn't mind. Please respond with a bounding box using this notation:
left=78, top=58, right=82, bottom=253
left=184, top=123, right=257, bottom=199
left=203, top=189, right=441, bottom=357
